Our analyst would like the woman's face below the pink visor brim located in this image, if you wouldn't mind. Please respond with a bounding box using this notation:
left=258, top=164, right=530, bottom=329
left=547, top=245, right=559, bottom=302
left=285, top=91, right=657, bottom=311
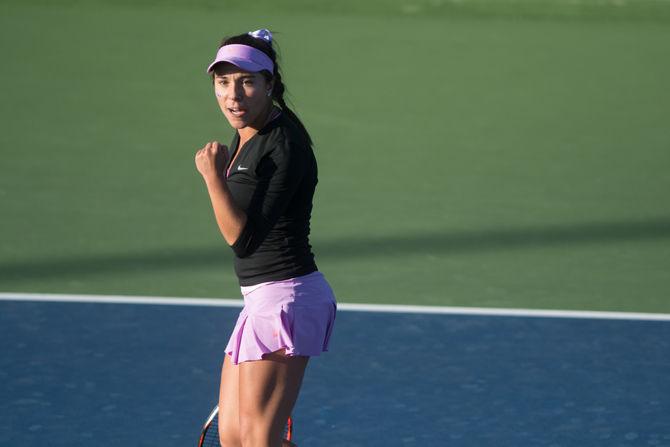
left=214, top=63, right=272, bottom=129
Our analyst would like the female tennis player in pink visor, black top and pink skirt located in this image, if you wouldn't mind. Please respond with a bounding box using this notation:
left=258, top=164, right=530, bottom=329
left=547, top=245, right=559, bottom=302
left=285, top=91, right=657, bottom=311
left=195, top=29, right=336, bottom=447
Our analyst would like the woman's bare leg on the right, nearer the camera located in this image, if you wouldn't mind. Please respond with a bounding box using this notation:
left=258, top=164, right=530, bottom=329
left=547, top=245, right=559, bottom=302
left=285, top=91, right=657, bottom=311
left=239, top=350, right=309, bottom=447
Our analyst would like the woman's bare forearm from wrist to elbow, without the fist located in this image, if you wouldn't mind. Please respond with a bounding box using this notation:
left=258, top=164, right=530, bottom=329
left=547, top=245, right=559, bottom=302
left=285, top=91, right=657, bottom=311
left=205, top=176, right=247, bottom=245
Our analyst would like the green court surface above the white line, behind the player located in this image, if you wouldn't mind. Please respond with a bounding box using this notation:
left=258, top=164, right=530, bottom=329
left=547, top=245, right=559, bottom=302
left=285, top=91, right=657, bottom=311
left=0, top=0, right=670, bottom=312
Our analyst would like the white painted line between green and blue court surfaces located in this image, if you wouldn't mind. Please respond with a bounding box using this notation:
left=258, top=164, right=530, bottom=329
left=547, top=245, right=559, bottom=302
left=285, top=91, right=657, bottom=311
left=0, top=292, right=670, bottom=321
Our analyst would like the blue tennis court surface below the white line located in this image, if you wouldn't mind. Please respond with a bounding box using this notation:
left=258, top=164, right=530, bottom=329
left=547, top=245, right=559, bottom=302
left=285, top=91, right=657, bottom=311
left=0, top=299, right=670, bottom=447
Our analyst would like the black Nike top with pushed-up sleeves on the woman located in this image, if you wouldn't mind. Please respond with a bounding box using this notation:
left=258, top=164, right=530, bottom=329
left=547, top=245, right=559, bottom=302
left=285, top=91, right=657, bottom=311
left=226, top=113, right=317, bottom=286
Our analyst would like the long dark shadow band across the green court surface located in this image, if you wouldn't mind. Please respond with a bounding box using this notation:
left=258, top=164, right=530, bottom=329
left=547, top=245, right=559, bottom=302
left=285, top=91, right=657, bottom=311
left=0, top=217, right=670, bottom=283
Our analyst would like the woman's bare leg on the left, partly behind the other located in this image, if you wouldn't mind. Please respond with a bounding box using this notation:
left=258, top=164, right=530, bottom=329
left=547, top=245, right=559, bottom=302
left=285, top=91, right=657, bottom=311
left=219, top=354, right=242, bottom=447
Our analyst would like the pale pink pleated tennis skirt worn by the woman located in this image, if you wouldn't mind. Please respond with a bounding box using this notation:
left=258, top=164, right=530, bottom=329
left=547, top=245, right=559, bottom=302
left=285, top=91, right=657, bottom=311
left=226, top=271, right=337, bottom=365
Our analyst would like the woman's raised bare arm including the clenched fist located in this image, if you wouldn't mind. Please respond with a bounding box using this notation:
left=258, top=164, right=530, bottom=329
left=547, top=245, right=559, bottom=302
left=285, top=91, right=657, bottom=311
left=195, top=141, right=247, bottom=245
